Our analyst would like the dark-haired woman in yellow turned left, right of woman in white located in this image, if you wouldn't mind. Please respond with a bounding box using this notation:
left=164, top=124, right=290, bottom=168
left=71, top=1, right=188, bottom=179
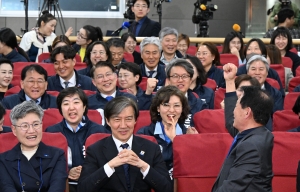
left=73, top=25, right=103, bottom=62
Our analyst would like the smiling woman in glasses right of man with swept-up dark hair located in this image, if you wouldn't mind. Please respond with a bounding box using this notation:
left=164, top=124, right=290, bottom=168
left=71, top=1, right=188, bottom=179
left=78, top=41, right=111, bottom=77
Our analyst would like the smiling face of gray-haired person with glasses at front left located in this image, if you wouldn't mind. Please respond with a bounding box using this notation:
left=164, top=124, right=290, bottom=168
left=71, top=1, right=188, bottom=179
left=11, top=113, right=43, bottom=151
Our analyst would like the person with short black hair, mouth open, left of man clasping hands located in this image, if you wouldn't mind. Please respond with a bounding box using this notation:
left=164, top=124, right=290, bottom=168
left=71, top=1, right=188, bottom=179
left=46, top=87, right=108, bottom=192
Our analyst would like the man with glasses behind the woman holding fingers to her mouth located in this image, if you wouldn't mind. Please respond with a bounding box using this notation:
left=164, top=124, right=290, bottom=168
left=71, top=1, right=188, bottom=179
left=166, top=59, right=209, bottom=128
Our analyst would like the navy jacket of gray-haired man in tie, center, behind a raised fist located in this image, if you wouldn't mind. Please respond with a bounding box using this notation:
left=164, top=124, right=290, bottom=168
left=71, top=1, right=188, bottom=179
left=140, top=61, right=167, bottom=92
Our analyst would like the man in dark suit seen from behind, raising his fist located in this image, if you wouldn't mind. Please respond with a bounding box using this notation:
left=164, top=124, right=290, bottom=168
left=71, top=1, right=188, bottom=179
left=212, top=63, right=273, bottom=192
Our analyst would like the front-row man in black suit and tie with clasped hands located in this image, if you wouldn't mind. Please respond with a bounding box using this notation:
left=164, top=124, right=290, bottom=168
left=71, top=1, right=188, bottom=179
left=78, top=96, right=172, bottom=192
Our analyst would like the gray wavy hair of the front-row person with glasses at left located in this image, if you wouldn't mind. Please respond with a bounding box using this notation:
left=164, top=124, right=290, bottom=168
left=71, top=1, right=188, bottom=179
left=10, top=101, right=44, bottom=125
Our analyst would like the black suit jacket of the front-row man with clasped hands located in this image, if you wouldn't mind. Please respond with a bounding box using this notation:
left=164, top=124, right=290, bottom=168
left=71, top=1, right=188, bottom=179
left=77, top=136, right=172, bottom=192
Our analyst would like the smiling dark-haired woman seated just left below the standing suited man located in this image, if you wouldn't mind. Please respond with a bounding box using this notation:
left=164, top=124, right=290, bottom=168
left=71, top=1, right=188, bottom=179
left=121, top=32, right=143, bottom=64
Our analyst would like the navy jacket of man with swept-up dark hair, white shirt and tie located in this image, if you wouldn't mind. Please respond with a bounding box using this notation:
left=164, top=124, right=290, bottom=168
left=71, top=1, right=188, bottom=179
left=47, top=70, right=97, bottom=91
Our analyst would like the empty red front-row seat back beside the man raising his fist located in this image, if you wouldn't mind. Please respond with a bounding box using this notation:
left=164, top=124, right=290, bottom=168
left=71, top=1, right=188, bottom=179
left=173, top=133, right=233, bottom=192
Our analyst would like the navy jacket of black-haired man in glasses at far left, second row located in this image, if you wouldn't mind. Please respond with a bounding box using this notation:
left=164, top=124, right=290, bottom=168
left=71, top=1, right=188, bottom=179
left=1, top=89, right=57, bottom=109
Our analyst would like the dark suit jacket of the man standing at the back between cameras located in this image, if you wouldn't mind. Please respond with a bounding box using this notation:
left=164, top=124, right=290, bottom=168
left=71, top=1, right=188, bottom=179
left=128, top=16, right=161, bottom=37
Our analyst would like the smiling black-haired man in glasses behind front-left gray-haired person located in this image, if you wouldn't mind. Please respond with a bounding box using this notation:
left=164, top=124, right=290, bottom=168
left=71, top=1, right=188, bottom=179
left=2, top=64, right=56, bottom=109
